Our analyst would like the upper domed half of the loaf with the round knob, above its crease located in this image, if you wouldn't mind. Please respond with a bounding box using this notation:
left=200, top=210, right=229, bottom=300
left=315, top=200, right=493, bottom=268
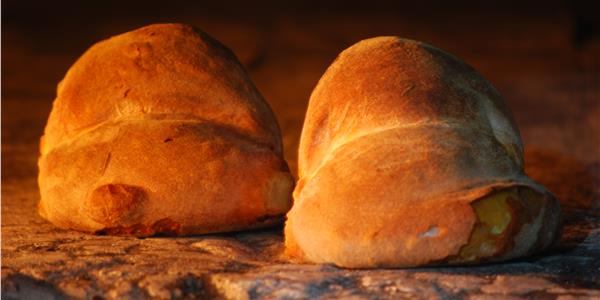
left=42, top=24, right=281, bottom=154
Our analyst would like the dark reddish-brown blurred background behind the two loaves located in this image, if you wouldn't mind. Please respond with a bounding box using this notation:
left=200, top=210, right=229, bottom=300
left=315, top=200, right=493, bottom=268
left=2, top=0, right=600, bottom=177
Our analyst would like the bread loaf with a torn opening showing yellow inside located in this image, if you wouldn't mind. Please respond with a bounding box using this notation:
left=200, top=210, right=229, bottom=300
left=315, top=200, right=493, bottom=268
left=285, top=37, right=560, bottom=268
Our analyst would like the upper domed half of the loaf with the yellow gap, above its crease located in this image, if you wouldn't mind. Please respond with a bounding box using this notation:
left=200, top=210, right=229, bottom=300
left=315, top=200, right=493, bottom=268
left=298, top=37, right=523, bottom=177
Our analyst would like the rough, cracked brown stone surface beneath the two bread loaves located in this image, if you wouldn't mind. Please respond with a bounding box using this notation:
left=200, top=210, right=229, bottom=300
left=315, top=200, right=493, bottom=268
left=2, top=164, right=600, bottom=299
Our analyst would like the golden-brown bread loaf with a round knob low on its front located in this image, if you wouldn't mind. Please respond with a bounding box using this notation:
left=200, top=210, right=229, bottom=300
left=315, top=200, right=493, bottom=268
left=39, top=24, right=293, bottom=236
